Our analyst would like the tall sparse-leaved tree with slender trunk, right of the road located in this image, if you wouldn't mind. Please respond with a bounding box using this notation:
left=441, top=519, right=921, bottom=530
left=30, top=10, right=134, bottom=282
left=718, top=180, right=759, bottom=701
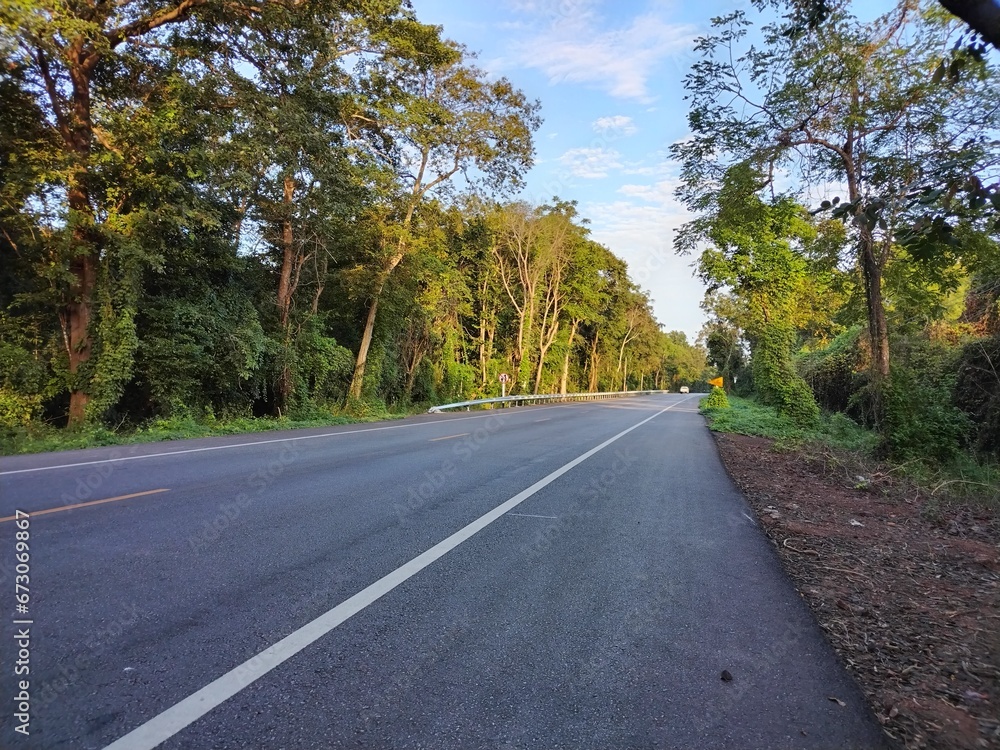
left=674, top=2, right=996, bottom=418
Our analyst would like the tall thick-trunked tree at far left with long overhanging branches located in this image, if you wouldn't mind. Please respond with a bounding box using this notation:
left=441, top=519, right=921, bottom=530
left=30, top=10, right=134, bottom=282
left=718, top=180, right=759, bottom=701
left=0, top=0, right=434, bottom=424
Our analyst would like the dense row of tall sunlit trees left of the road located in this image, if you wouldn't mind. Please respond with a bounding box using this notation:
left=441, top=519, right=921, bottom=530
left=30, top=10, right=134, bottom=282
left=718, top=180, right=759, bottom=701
left=0, top=0, right=705, bottom=446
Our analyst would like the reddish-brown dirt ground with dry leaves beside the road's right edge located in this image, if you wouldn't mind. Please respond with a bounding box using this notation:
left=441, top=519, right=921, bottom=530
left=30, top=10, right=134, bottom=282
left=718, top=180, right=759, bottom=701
left=716, top=433, right=1000, bottom=750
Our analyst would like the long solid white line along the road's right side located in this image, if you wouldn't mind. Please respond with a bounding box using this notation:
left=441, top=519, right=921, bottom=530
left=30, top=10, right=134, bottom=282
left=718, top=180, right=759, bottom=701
left=105, top=402, right=696, bottom=750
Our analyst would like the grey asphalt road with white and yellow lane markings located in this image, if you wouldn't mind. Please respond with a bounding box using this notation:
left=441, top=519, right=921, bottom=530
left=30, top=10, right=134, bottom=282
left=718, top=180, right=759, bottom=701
left=0, top=394, right=883, bottom=750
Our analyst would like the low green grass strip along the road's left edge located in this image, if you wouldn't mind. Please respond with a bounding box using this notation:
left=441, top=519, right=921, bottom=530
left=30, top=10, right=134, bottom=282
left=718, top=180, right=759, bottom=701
left=0, top=401, right=423, bottom=456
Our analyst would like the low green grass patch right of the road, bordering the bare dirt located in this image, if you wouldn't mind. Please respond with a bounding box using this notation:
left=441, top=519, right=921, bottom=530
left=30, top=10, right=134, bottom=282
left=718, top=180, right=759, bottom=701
left=701, top=396, right=879, bottom=454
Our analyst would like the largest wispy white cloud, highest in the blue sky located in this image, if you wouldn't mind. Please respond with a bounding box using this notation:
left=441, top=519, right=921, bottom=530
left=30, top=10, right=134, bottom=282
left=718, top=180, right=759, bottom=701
left=513, top=7, right=695, bottom=101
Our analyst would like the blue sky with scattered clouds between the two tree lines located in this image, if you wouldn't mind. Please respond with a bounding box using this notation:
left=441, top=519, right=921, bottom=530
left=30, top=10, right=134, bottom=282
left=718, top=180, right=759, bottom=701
left=413, top=0, right=750, bottom=341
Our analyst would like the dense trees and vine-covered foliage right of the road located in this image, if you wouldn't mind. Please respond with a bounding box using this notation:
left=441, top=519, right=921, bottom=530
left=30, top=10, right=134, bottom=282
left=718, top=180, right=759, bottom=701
left=673, top=0, right=1000, bottom=464
